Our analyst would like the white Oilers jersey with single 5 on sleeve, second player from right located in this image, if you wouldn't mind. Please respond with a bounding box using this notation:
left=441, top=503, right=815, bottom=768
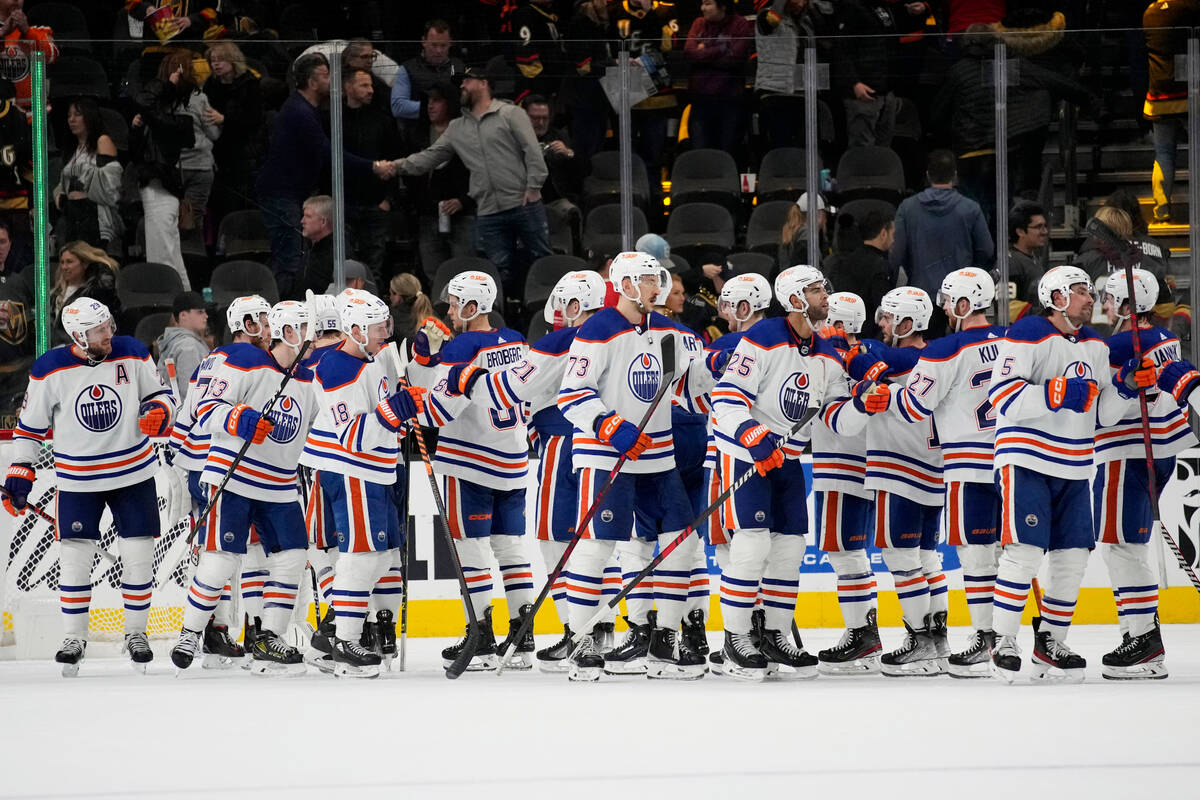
left=988, top=317, right=1136, bottom=480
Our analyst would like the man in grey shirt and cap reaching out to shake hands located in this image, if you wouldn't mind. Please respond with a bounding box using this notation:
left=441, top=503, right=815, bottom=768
left=395, top=61, right=550, bottom=302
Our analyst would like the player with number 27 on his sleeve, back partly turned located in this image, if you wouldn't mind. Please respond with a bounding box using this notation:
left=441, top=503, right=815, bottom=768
left=895, top=267, right=1004, bottom=678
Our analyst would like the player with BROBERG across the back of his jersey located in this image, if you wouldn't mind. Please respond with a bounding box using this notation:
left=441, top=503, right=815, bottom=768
left=409, top=272, right=535, bottom=670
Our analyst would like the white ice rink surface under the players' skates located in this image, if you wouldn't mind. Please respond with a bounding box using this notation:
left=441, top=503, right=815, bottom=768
left=0, top=625, right=1200, bottom=800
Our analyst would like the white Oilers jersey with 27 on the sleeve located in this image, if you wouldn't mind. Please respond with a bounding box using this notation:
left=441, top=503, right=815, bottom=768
left=893, top=325, right=1004, bottom=483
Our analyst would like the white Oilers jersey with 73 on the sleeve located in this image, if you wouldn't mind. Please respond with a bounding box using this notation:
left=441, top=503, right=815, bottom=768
left=558, top=308, right=713, bottom=475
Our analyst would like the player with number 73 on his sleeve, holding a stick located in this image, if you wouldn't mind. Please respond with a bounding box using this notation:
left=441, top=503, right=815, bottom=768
left=558, top=252, right=713, bottom=680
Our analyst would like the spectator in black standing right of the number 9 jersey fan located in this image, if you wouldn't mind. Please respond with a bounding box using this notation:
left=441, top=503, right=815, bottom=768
left=558, top=0, right=613, bottom=161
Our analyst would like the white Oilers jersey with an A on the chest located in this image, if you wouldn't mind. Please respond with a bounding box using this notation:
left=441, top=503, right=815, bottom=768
left=12, top=336, right=175, bottom=492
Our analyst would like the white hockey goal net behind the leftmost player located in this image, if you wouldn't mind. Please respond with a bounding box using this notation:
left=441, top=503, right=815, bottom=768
left=0, top=440, right=190, bottom=644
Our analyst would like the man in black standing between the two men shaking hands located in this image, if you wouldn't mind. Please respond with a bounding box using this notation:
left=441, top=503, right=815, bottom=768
left=342, top=67, right=401, bottom=283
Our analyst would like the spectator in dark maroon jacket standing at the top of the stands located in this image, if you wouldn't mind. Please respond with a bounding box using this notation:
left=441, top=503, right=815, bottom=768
left=684, top=0, right=754, bottom=152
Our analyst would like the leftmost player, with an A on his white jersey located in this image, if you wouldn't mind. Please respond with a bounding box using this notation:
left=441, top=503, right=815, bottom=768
left=4, top=297, right=175, bottom=676
